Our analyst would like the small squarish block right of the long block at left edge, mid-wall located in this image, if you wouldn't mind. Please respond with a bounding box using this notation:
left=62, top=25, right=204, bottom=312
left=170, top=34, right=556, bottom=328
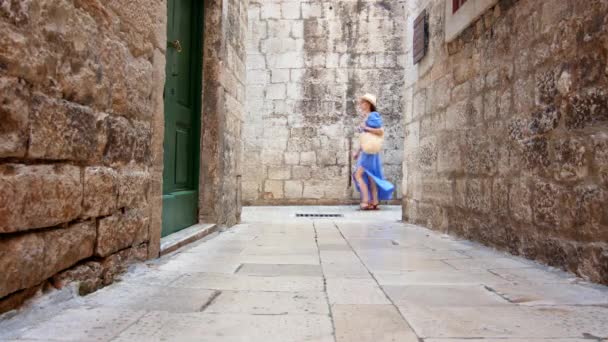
left=83, top=167, right=118, bottom=217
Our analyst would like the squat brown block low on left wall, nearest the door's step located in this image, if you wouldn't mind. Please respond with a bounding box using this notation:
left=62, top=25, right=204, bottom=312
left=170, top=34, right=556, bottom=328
left=95, top=209, right=149, bottom=257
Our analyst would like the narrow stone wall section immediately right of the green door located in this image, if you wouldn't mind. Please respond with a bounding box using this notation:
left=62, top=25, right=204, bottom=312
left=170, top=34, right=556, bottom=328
left=199, top=0, right=248, bottom=226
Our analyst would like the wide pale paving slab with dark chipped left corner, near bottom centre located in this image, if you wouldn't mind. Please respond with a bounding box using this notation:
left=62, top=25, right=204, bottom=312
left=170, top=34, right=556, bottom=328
left=204, top=291, right=329, bottom=315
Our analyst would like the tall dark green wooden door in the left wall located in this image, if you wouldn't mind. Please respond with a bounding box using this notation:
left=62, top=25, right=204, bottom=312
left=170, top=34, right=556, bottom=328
left=162, top=0, right=202, bottom=236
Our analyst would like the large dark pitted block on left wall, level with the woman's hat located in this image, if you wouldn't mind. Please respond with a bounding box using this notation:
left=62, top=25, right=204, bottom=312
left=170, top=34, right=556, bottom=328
left=28, top=94, right=106, bottom=162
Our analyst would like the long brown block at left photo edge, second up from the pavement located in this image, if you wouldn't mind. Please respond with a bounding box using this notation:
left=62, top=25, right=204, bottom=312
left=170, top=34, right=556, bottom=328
left=0, top=164, right=83, bottom=233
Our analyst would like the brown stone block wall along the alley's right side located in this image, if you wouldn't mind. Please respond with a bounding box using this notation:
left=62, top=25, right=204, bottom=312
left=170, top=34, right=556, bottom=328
left=403, top=0, right=608, bottom=283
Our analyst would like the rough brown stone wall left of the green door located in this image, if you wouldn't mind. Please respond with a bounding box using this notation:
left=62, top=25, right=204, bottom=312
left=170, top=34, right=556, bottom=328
left=0, top=0, right=166, bottom=312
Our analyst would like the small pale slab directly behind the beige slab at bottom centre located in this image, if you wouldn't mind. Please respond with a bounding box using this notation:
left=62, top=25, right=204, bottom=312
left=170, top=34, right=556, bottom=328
left=327, top=278, right=390, bottom=304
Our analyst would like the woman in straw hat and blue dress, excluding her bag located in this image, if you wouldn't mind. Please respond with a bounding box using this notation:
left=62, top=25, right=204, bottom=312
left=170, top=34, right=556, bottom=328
left=353, top=94, right=395, bottom=210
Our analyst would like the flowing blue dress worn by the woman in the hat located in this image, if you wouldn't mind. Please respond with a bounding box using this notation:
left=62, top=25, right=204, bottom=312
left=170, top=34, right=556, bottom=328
left=353, top=112, right=395, bottom=201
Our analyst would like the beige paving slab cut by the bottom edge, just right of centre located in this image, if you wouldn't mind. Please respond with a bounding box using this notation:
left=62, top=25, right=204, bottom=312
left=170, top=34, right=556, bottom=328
left=332, top=305, right=419, bottom=342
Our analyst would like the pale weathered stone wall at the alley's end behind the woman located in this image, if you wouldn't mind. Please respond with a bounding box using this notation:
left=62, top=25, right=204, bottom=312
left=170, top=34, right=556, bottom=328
left=243, top=0, right=405, bottom=204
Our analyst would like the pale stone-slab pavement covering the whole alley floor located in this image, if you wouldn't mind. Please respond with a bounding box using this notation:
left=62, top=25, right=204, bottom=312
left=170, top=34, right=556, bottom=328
left=0, top=207, right=608, bottom=342
